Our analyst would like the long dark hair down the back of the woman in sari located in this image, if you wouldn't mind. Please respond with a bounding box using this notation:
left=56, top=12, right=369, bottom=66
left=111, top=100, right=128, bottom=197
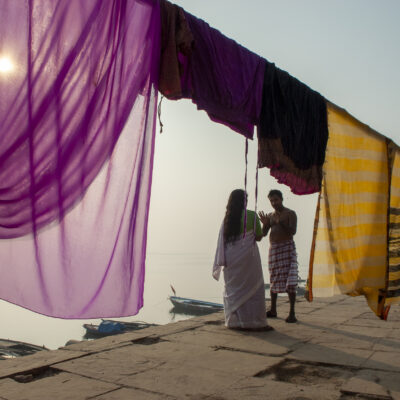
left=224, top=189, right=246, bottom=243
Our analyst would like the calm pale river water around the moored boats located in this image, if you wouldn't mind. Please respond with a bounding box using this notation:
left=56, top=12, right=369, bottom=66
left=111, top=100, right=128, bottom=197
left=0, top=254, right=307, bottom=349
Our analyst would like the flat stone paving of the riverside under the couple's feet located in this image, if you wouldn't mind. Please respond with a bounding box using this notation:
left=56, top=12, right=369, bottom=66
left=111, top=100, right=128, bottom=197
left=0, top=296, right=400, bottom=400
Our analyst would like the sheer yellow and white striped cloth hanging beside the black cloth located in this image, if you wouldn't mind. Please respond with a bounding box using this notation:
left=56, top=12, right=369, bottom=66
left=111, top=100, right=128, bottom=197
left=309, top=104, right=390, bottom=315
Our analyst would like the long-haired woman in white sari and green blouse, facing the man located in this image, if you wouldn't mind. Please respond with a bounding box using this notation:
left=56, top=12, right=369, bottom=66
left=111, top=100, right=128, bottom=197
left=213, top=189, right=272, bottom=331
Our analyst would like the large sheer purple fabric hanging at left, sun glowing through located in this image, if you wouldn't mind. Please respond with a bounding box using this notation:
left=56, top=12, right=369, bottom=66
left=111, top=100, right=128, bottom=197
left=0, top=0, right=160, bottom=318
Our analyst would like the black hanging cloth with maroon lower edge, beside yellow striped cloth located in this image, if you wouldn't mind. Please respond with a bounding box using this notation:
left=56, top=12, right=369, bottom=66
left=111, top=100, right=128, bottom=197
left=257, top=62, right=328, bottom=194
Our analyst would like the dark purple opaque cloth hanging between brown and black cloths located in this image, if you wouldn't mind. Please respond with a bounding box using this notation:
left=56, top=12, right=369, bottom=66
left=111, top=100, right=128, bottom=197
left=181, top=12, right=265, bottom=139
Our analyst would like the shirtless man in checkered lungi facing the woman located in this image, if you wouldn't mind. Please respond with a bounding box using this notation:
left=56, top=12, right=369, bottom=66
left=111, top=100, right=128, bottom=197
left=259, top=190, right=298, bottom=323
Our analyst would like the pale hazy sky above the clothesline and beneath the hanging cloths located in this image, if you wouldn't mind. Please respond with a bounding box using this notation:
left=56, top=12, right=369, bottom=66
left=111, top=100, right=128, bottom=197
left=148, top=0, right=400, bottom=262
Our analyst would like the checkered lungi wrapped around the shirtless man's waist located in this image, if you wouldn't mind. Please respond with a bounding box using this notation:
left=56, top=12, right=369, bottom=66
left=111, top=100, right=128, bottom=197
left=268, top=240, right=298, bottom=293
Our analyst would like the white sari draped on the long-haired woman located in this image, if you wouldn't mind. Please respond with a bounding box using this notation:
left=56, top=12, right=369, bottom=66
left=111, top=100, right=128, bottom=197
left=213, top=224, right=267, bottom=328
